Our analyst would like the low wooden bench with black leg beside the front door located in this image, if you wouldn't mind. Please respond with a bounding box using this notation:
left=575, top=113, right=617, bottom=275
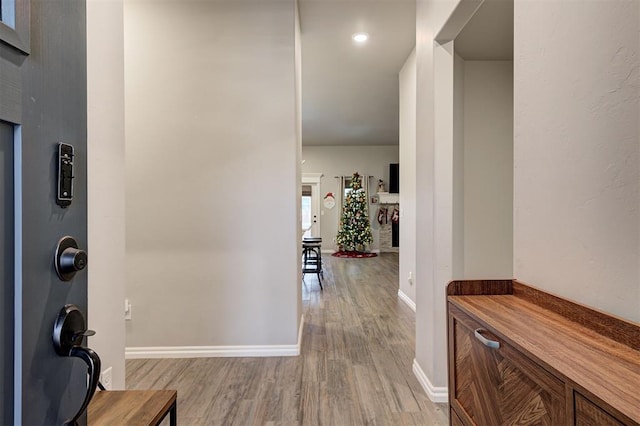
left=87, top=390, right=178, bottom=426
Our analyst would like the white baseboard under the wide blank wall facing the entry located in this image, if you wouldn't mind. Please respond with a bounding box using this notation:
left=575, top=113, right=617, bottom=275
left=124, top=315, right=304, bottom=359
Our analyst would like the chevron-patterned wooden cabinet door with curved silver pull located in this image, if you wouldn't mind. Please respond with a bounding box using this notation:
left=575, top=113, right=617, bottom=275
left=449, top=306, right=566, bottom=426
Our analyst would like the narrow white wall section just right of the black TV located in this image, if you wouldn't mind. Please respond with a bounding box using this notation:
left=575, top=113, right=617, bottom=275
left=399, top=49, right=416, bottom=304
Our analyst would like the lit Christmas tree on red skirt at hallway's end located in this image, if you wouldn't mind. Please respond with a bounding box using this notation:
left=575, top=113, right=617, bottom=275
left=336, top=172, right=373, bottom=251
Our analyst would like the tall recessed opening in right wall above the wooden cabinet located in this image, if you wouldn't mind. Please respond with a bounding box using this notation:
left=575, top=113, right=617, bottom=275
left=434, top=0, right=514, bottom=279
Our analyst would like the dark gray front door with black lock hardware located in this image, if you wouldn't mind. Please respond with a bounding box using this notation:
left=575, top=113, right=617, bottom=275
left=0, top=0, right=87, bottom=425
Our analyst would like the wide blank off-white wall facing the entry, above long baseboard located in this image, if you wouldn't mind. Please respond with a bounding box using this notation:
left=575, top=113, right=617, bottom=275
left=125, top=0, right=300, bottom=352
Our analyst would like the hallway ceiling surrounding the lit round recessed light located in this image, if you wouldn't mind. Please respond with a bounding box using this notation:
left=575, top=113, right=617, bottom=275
left=299, top=0, right=416, bottom=145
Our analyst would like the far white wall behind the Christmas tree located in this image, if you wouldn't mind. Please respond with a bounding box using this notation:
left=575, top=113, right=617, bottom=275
left=302, top=145, right=402, bottom=250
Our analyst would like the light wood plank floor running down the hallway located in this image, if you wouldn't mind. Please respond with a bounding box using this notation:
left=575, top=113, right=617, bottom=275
left=126, top=253, right=449, bottom=426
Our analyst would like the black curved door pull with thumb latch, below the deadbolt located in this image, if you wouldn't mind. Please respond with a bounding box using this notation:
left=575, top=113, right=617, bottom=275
left=53, top=305, right=101, bottom=426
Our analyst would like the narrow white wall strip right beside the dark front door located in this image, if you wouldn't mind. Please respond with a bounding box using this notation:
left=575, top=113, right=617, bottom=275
left=87, top=0, right=126, bottom=389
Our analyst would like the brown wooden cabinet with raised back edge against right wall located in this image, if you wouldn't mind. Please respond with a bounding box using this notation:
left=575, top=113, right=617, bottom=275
left=447, top=280, right=640, bottom=426
